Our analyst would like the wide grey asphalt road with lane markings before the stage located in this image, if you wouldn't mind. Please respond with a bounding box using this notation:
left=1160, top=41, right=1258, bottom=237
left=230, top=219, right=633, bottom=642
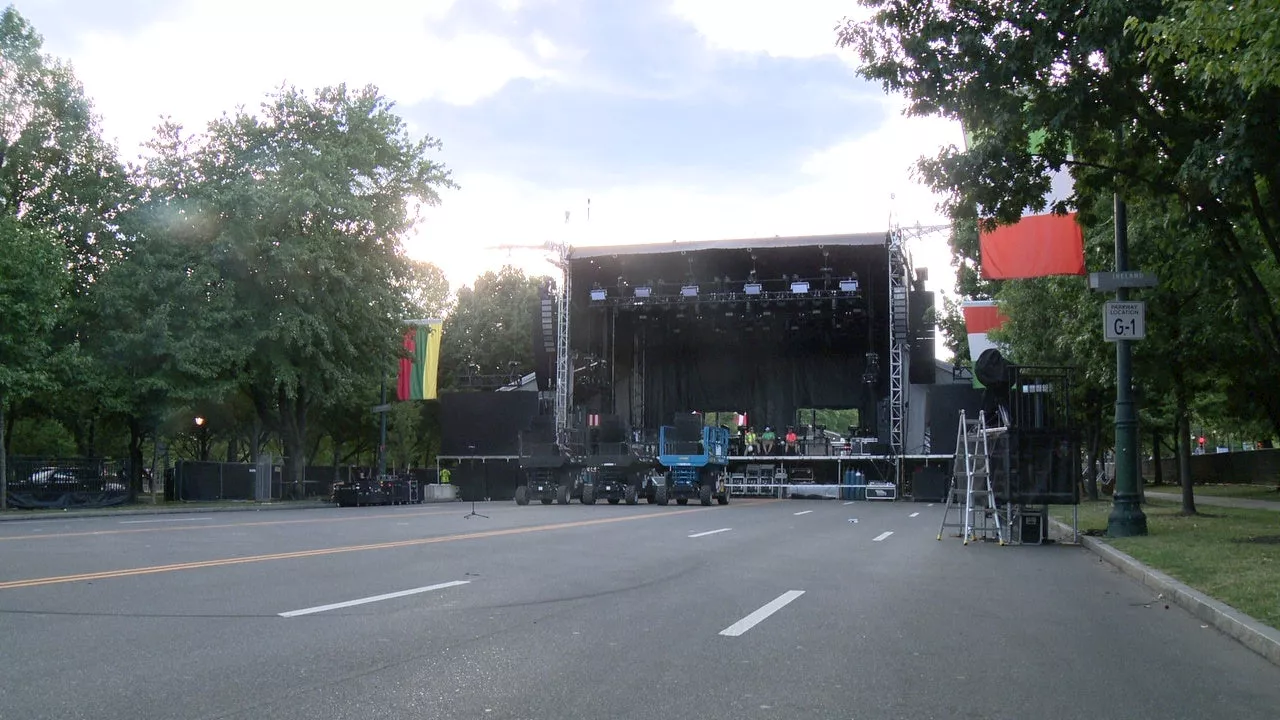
left=0, top=500, right=1280, bottom=720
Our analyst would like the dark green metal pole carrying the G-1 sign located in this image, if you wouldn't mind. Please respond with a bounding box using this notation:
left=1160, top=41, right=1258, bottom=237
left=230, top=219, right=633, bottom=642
left=1107, top=192, right=1147, bottom=538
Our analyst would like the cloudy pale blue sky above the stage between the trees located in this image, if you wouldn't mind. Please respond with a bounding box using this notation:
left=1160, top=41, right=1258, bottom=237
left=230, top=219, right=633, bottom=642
left=14, top=0, right=961, bottom=302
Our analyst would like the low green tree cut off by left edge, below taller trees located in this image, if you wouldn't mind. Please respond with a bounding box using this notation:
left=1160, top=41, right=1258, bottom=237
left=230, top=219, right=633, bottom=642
left=0, top=217, right=70, bottom=510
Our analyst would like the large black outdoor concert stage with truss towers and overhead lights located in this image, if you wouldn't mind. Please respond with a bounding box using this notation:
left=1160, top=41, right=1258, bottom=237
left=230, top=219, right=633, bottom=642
left=442, top=233, right=973, bottom=497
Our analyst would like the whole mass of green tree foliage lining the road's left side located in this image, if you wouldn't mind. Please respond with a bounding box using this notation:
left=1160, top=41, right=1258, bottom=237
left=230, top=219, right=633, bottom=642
left=0, top=8, right=471, bottom=499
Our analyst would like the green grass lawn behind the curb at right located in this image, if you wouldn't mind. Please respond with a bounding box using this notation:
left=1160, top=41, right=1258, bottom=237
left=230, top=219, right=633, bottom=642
left=1052, top=499, right=1280, bottom=628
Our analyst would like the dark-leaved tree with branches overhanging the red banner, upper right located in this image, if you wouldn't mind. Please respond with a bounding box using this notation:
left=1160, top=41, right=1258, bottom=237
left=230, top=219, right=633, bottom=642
left=838, top=0, right=1280, bottom=430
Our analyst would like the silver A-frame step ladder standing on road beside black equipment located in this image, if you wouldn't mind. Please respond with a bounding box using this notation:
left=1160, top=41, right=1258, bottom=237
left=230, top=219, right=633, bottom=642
left=938, top=410, right=1009, bottom=544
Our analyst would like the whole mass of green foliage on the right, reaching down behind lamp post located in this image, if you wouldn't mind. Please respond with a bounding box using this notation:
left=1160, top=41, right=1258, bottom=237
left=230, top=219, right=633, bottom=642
left=837, top=0, right=1280, bottom=502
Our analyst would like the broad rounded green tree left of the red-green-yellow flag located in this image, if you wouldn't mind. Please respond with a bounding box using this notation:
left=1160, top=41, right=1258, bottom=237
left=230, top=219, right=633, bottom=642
left=140, top=86, right=452, bottom=493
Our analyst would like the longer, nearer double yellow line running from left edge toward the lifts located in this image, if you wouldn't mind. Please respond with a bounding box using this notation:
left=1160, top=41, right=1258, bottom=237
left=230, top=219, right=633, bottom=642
left=0, top=507, right=705, bottom=591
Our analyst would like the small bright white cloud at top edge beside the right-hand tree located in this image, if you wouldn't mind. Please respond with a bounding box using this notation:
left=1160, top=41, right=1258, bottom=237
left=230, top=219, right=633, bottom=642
left=669, top=0, right=867, bottom=58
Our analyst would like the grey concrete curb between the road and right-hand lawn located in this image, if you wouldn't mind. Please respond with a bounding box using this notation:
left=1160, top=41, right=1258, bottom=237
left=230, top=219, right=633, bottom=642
left=1050, top=518, right=1280, bottom=666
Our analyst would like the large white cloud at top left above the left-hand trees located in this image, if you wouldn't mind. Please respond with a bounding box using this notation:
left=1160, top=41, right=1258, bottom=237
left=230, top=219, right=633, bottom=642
left=60, top=0, right=549, bottom=156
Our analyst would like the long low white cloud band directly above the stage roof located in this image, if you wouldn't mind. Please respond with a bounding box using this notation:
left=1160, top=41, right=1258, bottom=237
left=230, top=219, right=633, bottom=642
left=407, top=96, right=960, bottom=295
